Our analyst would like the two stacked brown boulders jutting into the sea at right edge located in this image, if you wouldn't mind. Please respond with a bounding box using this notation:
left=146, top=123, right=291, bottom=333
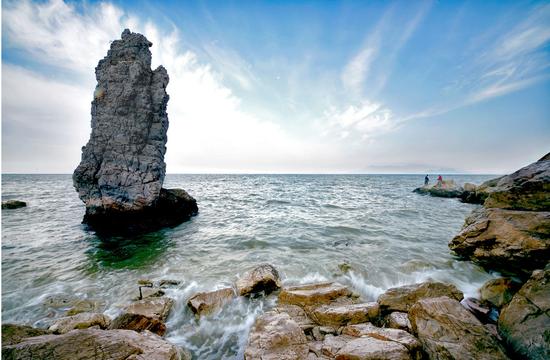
left=449, top=155, right=550, bottom=277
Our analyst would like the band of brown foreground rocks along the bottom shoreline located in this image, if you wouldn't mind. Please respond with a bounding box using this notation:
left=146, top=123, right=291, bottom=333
left=2, top=264, right=550, bottom=360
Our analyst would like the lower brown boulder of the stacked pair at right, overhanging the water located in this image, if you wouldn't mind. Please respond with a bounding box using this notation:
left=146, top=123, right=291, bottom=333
left=449, top=208, right=550, bottom=275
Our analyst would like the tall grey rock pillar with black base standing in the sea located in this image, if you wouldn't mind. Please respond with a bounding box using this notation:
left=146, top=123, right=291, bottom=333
left=73, top=29, right=198, bottom=232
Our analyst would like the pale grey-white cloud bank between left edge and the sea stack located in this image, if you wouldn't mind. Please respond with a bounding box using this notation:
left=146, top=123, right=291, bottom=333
left=2, top=64, right=91, bottom=173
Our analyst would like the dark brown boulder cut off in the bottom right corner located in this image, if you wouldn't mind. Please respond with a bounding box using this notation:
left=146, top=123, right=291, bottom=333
left=498, top=267, right=550, bottom=360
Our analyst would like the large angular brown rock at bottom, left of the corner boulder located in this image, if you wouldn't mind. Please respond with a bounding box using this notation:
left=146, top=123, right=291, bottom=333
left=409, top=296, right=508, bottom=359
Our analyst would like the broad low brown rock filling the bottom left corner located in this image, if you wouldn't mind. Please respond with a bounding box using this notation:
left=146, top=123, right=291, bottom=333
left=2, top=329, right=184, bottom=360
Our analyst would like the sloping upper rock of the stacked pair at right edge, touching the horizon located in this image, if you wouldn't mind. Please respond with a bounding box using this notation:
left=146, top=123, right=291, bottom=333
left=479, top=156, right=550, bottom=211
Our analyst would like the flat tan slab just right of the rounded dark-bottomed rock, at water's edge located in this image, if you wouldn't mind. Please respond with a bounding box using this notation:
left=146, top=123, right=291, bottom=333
left=279, top=282, right=352, bottom=307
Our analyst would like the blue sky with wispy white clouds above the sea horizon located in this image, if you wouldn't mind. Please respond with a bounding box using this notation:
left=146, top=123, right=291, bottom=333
left=2, top=0, right=550, bottom=174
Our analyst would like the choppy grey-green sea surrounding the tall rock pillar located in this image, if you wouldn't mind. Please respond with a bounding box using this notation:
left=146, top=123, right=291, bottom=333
left=2, top=175, right=496, bottom=359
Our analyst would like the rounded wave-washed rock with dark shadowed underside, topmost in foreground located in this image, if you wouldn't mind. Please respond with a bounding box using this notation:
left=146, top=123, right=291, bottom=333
left=235, top=264, right=281, bottom=296
